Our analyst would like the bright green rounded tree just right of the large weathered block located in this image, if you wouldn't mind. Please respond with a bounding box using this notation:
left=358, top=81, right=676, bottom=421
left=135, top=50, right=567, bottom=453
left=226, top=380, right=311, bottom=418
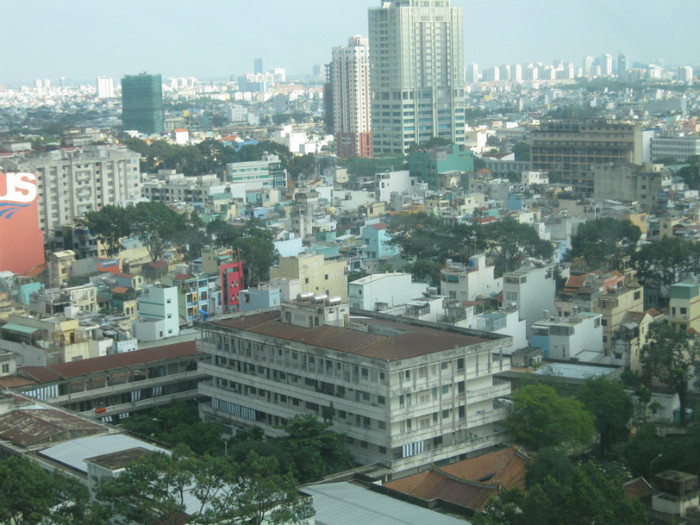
left=505, top=384, right=595, bottom=450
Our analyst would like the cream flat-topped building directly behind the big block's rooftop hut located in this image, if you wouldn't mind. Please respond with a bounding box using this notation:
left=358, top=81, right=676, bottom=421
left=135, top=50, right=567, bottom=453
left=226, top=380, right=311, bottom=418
left=270, top=254, right=348, bottom=301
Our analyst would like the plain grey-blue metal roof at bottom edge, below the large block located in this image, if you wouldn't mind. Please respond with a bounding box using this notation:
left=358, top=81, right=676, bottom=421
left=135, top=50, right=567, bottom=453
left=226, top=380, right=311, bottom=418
left=301, top=483, right=470, bottom=525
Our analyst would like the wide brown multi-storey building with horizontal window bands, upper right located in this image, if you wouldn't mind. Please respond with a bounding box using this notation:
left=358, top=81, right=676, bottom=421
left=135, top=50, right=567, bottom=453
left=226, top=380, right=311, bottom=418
left=530, top=120, right=643, bottom=194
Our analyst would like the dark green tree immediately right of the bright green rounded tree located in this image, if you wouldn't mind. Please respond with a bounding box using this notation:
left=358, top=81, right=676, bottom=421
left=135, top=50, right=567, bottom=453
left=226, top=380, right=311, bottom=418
left=578, top=376, right=634, bottom=456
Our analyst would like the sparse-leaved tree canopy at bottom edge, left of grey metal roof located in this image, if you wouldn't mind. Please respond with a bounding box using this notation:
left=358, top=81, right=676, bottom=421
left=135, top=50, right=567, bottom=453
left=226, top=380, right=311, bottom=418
left=96, top=447, right=313, bottom=525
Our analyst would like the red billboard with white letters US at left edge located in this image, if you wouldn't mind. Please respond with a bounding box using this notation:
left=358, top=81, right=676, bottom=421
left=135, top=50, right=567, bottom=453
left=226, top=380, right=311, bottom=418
left=0, top=172, right=44, bottom=274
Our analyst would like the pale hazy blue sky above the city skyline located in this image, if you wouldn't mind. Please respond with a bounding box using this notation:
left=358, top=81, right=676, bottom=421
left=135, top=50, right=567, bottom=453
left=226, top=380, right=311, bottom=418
left=0, top=0, right=700, bottom=85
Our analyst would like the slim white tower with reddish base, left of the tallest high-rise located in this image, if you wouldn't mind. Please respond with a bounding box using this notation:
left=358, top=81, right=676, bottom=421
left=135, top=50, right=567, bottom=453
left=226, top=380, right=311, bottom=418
left=329, top=36, right=372, bottom=158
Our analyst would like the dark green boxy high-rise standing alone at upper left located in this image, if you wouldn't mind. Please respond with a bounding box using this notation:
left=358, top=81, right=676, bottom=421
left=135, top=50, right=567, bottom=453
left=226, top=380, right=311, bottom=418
left=122, top=73, right=163, bottom=135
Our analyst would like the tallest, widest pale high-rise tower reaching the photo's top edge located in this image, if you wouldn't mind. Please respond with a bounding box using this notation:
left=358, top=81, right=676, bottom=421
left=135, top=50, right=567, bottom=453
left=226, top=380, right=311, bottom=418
left=369, top=0, right=464, bottom=155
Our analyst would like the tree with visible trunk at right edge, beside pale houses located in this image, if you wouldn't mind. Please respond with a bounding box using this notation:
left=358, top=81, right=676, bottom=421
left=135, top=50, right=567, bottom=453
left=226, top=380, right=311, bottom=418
left=640, top=323, right=700, bottom=425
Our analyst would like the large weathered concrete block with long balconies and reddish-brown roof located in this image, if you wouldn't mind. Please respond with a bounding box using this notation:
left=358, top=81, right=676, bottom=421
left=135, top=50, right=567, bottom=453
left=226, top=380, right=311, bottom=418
left=194, top=302, right=510, bottom=471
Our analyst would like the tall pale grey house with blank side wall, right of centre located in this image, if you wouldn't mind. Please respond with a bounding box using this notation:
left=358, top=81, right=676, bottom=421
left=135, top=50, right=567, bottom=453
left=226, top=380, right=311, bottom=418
left=503, top=264, right=556, bottom=337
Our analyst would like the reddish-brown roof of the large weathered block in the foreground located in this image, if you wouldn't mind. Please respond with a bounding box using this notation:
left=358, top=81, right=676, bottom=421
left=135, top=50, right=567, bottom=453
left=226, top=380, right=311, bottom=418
left=212, top=310, right=489, bottom=361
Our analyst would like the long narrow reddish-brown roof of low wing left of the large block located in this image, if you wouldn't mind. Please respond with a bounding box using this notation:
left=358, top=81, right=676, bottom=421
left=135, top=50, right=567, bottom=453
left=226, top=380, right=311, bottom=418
left=20, top=341, right=201, bottom=383
